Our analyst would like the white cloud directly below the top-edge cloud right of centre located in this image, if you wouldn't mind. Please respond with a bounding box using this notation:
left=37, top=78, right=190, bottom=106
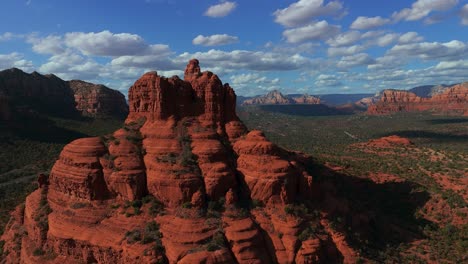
left=283, top=20, right=340, bottom=43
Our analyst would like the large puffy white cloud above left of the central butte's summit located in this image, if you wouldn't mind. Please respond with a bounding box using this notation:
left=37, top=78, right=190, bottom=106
left=65, top=30, right=154, bottom=57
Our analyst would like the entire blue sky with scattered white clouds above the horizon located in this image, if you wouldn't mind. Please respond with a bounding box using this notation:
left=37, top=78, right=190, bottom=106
left=0, top=0, right=468, bottom=95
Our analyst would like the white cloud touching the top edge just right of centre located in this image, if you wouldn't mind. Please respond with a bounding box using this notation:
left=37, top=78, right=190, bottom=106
left=273, top=0, right=345, bottom=27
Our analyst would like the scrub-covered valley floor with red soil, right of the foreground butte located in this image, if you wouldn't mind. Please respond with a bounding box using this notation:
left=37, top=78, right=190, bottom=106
left=238, top=106, right=468, bottom=263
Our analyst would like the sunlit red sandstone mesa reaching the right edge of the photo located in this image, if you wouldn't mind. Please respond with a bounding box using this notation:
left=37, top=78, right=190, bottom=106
left=367, top=82, right=468, bottom=116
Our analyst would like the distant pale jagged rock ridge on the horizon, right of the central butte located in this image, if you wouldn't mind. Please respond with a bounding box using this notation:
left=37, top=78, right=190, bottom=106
left=242, top=90, right=320, bottom=105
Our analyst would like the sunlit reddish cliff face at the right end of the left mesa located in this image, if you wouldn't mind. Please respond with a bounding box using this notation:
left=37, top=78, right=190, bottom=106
left=68, top=80, right=128, bottom=117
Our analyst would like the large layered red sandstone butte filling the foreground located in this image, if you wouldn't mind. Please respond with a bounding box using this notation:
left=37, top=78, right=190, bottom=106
left=1, top=59, right=358, bottom=263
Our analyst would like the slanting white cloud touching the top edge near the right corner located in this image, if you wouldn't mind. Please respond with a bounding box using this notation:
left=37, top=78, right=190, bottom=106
left=392, top=0, right=458, bottom=21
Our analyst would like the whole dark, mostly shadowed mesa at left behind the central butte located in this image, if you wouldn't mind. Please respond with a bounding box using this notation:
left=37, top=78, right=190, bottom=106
left=0, top=68, right=128, bottom=120
